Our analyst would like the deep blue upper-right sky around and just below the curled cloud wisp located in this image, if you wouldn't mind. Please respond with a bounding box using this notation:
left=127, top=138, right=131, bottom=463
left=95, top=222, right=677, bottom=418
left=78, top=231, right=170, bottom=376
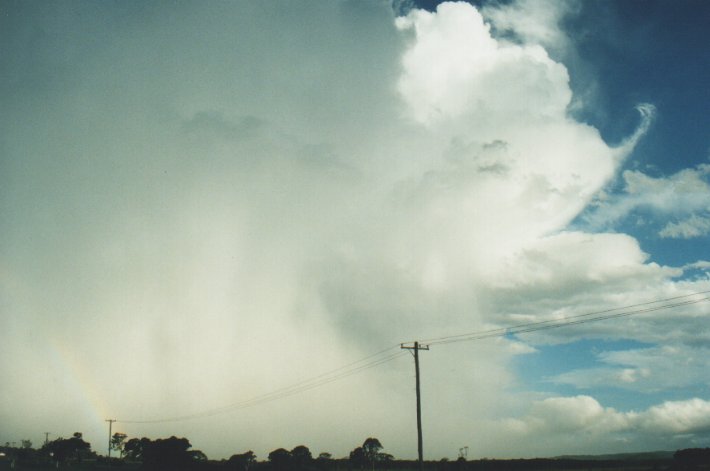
left=571, top=1, right=710, bottom=265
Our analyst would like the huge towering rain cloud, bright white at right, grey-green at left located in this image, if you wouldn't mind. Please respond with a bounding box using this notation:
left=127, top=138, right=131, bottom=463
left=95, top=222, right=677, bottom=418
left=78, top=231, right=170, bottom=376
left=0, top=2, right=710, bottom=457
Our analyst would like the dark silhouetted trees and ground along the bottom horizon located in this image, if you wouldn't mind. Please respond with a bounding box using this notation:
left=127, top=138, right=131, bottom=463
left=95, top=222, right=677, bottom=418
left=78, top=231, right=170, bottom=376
left=0, top=438, right=710, bottom=471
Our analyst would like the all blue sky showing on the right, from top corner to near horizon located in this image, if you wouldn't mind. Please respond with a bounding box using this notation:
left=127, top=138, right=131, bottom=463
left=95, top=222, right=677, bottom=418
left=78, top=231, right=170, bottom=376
left=472, top=1, right=710, bottom=432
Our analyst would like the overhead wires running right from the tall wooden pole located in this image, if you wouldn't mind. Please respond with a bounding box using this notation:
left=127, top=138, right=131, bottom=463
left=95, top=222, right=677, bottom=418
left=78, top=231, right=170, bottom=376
left=420, top=291, right=710, bottom=345
